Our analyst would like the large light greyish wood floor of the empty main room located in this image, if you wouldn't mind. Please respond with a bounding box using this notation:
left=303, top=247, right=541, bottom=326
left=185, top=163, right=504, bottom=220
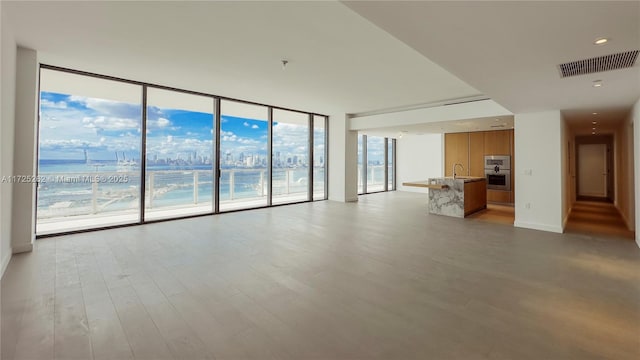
left=2, top=192, right=640, bottom=360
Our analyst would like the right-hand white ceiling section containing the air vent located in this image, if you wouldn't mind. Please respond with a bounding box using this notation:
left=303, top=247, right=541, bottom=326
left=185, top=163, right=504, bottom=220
left=344, top=1, right=640, bottom=132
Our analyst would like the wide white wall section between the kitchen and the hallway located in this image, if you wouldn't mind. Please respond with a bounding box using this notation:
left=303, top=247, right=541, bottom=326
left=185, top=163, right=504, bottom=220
left=514, top=111, right=566, bottom=233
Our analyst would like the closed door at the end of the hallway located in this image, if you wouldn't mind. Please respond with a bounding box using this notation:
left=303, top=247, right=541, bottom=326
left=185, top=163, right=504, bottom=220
left=578, top=144, right=607, bottom=197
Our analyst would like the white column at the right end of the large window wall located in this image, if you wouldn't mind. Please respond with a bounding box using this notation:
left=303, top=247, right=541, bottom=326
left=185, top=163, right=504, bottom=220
left=328, top=114, right=358, bottom=202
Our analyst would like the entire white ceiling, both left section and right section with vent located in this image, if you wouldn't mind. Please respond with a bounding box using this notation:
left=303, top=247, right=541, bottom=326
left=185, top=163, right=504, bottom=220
left=0, top=1, right=640, bottom=136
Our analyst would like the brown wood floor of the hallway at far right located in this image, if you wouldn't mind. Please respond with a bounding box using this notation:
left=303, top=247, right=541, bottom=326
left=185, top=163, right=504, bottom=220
left=565, top=201, right=634, bottom=240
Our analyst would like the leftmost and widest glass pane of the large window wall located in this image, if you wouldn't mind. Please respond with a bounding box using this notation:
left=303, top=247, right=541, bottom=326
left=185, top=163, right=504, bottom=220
left=36, top=69, right=142, bottom=234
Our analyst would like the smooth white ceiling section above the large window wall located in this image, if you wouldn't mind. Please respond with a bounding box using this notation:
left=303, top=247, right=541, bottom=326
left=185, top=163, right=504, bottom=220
left=0, top=1, right=480, bottom=115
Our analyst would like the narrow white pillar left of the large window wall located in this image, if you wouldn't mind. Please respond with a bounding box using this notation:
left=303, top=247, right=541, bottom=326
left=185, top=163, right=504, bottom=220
left=11, top=47, right=38, bottom=254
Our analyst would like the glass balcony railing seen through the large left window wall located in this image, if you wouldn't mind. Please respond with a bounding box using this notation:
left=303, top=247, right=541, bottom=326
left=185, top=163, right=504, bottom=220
left=37, top=168, right=324, bottom=220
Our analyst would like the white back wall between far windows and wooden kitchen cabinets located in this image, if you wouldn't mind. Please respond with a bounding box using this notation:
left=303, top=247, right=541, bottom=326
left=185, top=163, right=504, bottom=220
left=396, top=134, right=444, bottom=193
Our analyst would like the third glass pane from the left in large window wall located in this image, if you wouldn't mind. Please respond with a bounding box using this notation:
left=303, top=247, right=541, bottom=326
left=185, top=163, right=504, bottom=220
left=220, top=100, right=269, bottom=211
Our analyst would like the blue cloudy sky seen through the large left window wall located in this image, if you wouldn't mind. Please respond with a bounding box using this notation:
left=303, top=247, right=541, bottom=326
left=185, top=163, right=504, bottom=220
left=39, top=92, right=324, bottom=160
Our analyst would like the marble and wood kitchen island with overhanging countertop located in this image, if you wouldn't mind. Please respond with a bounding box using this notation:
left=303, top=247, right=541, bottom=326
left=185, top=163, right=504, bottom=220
left=402, top=176, right=487, bottom=218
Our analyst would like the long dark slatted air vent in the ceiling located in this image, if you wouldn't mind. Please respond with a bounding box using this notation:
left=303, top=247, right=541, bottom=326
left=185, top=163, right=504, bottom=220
left=558, top=50, right=640, bottom=78
